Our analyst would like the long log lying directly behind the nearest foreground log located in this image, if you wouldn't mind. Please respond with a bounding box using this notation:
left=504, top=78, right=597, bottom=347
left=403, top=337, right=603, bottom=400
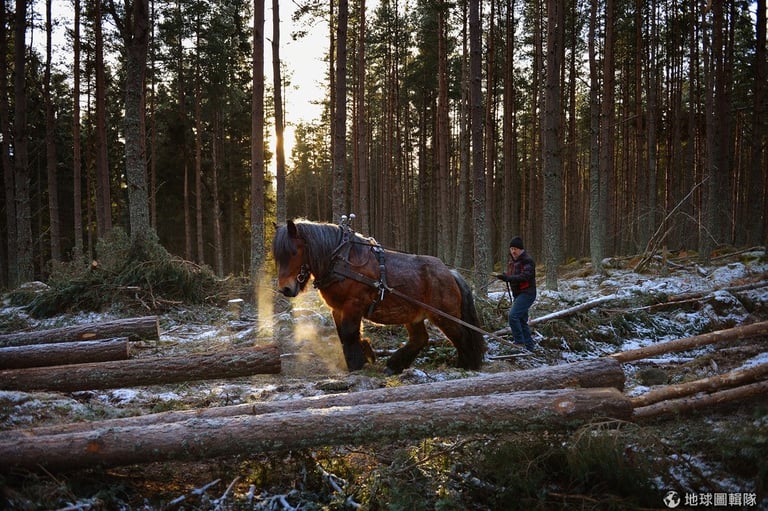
left=2, top=358, right=625, bottom=438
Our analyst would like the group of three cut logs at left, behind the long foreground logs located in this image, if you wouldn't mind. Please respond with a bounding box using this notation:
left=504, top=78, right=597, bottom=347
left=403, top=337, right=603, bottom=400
left=0, top=316, right=281, bottom=392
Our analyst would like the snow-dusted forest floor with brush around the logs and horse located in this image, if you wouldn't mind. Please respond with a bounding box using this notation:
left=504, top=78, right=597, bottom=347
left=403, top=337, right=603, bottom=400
left=0, top=248, right=768, bottom=510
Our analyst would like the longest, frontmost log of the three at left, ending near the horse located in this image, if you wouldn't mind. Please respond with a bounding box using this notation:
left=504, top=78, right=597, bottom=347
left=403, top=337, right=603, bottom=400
left=0, top=345, right=280, bottom=392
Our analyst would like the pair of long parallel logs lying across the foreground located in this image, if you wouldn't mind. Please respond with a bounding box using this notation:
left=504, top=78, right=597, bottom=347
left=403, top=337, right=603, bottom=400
left=0, top=359, right=632, bottom=470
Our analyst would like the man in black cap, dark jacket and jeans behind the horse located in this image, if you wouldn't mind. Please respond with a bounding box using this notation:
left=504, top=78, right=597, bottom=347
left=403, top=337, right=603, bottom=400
left=496, top=236, right=536, bottom=351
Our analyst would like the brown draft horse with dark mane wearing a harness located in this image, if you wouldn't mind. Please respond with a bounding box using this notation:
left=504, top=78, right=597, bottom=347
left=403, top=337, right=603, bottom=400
left=272, top=220, right=485, bottom=373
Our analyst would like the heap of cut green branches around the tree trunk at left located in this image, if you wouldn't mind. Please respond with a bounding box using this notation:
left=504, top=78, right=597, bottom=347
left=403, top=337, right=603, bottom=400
left=19, top=228, right=222, bottom=317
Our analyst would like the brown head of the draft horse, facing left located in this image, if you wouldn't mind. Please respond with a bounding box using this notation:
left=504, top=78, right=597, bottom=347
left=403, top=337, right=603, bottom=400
left=272, top=220, right=310, bottom=297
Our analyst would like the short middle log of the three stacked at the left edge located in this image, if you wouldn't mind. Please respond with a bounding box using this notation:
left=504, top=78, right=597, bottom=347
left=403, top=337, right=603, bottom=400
left=0, top=337, right=128, bottom=369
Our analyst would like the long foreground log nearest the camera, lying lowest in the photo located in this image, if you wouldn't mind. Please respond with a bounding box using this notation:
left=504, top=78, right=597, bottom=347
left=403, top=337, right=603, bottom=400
left=0, top=389, right=632, bottom=471
